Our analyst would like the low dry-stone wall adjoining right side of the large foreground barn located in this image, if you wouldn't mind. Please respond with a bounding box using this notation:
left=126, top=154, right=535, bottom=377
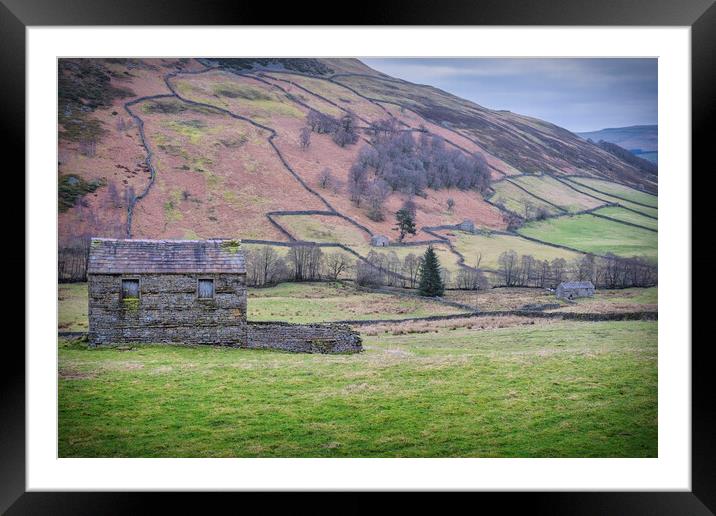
left=246, top=322, right=363, bottom=353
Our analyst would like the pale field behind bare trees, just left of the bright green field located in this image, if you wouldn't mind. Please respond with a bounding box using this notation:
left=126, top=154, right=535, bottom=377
left=443, top=230, right=579, bottom=269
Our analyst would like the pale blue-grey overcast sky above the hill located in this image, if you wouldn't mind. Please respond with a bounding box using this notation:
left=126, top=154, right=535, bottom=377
left=361, top=58, right=657, bottom=132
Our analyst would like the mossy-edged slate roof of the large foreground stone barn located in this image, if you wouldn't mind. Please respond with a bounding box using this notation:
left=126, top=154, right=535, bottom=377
left=87, top=238, right=246, bottom=274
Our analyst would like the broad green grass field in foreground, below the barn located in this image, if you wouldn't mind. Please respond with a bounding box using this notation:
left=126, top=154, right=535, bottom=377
left=59, top=318, right=657, bottom=457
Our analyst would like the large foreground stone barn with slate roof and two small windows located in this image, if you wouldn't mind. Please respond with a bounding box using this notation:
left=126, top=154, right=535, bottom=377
left=87, top=238, right=247, bottom=347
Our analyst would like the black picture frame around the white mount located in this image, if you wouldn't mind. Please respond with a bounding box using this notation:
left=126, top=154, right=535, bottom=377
left=0, top=0, right=716, bottom=515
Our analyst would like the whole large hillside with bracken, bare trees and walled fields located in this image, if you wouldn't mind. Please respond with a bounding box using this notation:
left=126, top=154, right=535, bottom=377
left=58, top=58, right=657, bottom=284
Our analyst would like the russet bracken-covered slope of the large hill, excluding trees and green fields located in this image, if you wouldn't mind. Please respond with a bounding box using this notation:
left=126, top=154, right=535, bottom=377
left=58, top=58, right=656, bottom=250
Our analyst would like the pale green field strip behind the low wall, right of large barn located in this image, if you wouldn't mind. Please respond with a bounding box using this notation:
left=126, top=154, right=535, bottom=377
left=248, top=283, right=464, bottom=323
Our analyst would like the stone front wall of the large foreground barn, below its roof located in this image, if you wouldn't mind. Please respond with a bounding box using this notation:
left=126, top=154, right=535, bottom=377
left=88, top=273, right=247, bottom=347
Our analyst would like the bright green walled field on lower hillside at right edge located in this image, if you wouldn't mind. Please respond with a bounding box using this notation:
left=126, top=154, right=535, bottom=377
left=518, top=214, right=657, bottom=263
